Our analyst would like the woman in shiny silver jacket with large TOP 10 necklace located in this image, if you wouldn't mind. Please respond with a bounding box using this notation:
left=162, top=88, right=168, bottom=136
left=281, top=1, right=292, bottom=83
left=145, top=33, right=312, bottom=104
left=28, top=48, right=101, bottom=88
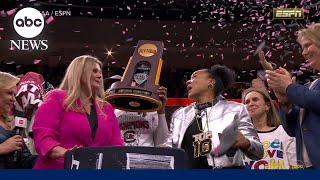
left=166, top=65, right=263, bottom=169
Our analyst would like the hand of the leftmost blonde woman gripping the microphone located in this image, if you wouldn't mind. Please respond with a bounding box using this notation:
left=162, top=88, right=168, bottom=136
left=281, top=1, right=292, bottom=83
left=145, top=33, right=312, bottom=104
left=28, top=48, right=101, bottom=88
left=0, top=135, right=23, bottom=154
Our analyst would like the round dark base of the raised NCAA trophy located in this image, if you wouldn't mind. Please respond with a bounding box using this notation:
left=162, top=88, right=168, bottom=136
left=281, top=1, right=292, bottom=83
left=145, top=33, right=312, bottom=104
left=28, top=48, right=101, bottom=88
left=105, top=94, right=162, bottom=112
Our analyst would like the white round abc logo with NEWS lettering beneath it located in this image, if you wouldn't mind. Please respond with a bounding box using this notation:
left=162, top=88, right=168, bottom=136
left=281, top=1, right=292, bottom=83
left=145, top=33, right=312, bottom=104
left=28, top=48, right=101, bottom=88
left=10, top=7, right=48, bottom=51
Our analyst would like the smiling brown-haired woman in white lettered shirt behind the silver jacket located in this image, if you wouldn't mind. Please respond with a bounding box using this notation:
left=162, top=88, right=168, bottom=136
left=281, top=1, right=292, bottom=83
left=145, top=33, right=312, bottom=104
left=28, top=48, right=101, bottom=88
left=242, top=88, right=297, bottom=169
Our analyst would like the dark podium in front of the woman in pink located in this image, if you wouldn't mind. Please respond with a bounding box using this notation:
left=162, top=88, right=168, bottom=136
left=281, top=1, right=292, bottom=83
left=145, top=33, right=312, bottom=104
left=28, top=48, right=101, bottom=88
left=64, top=146, right=187, bottom=169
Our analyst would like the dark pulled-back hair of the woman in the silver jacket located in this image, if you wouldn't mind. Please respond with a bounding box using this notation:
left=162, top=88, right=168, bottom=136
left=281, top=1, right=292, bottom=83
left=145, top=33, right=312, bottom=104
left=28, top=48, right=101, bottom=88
left=207, top=65, right=236, bottom=96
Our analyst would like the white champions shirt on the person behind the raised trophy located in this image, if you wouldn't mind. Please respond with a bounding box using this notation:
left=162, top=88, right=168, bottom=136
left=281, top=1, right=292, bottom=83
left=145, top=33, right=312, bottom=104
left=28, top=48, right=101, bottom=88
left=115, top=109, right=169, bottom=147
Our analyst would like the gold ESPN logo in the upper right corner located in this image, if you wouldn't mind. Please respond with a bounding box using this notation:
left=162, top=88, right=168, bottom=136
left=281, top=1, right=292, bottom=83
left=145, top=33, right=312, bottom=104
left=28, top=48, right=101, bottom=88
left=273, top=8, right=304, bottom=19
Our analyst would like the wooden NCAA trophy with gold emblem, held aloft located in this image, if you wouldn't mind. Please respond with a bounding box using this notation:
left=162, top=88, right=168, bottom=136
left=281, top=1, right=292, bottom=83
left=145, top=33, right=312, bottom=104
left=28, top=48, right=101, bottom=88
left=105, top=40, right=164, bottom=112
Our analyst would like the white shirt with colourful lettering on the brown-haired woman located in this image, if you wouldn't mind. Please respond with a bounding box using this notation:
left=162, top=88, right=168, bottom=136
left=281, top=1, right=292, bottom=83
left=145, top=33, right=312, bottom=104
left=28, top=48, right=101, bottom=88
left=245, top=125, right=297, bottom=169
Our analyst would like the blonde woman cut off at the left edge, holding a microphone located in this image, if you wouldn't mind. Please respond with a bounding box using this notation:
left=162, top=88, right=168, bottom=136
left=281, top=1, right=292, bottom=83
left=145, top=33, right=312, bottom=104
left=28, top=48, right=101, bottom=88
left=0, top=72, right=36, bottom=169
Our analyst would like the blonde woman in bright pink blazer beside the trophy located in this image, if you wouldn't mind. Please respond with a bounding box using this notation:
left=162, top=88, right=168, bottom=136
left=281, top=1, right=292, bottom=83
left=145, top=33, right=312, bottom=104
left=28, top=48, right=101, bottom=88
left=33, top=55, right=123, bottom=169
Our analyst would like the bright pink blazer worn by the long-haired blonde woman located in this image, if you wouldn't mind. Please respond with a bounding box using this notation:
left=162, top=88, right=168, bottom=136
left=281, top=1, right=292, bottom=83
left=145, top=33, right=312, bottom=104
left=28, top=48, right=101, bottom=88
left=32, top=89, right=123, bottom=169
